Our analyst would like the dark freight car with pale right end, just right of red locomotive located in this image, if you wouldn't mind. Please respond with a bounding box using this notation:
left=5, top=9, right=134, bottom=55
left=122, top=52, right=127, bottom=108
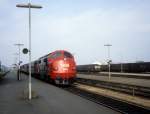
left=77, top=64, right=101, bottom=72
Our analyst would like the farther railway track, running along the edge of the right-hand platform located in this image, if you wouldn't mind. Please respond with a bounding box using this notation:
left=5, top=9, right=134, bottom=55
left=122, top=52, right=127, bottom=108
left=76, top=77, right=150, bottom=98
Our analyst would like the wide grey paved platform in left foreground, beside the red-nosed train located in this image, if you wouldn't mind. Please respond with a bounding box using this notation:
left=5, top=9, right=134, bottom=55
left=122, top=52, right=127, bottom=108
left=0, top=71, right=118, bottom=114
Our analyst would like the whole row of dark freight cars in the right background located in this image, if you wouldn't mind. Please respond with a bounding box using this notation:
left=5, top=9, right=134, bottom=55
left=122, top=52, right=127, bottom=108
left=77, top=62, right=150, bottom=73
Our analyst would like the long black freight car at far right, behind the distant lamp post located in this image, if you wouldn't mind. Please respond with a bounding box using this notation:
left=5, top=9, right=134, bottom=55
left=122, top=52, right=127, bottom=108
left=101, top=62, right=150, bottom=73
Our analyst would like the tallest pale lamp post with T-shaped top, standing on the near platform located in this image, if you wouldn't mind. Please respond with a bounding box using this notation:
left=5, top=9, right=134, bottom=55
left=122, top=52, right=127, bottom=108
left=16, top=0, right=42, bottom=100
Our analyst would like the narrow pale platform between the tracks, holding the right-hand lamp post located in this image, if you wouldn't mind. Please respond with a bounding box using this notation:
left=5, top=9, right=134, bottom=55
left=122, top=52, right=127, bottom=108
left=77, top=73, right=150, bottom=88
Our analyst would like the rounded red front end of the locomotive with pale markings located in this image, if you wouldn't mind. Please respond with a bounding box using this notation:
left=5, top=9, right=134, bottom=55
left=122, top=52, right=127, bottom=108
left=48, top=51, right=76, bottom=85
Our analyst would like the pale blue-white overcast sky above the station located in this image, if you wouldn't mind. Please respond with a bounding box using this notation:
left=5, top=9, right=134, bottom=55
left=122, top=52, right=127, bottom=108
left=0, top=0, right=150, bottom=65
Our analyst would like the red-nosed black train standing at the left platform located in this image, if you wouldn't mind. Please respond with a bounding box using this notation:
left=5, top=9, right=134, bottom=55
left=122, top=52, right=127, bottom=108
left=20, top=50, right=76, bottom=85
